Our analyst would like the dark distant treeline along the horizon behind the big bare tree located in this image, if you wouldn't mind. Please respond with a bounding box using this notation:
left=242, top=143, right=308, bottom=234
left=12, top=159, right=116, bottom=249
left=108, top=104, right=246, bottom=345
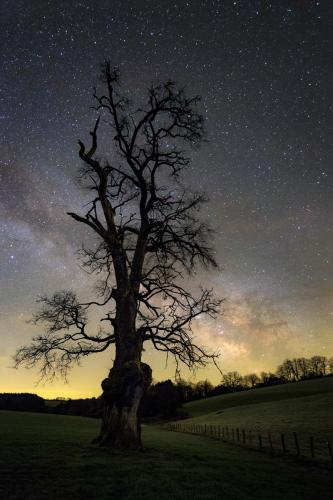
left=0, top=356, right=333, bottom=420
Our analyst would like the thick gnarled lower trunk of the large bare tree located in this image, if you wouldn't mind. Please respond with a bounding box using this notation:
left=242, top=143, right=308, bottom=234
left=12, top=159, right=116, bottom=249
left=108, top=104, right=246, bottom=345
left=94, top=292, right=152, bottom=450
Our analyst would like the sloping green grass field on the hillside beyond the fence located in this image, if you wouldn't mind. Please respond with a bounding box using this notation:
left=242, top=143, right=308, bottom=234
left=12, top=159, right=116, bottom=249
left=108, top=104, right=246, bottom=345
left=185, top=377, right=333, bottom=459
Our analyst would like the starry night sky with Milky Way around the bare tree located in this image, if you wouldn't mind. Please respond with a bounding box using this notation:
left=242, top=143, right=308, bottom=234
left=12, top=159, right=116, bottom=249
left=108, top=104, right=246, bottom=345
left=0, top=0, right=333, bottom=397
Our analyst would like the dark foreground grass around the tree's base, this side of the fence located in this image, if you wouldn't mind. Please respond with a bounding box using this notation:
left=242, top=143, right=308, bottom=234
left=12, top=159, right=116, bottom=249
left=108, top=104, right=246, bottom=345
left=0, top=412, right=333, bottom=500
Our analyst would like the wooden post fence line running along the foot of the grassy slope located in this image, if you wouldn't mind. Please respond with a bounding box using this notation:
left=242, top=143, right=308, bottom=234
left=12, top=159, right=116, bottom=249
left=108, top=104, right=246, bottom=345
left=164, top=422, right=333, bottom=464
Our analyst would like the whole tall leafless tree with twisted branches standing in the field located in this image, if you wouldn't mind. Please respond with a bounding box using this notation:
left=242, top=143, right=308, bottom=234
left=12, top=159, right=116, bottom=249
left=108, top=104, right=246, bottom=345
left=16, top=62, right=220, bottom=449
